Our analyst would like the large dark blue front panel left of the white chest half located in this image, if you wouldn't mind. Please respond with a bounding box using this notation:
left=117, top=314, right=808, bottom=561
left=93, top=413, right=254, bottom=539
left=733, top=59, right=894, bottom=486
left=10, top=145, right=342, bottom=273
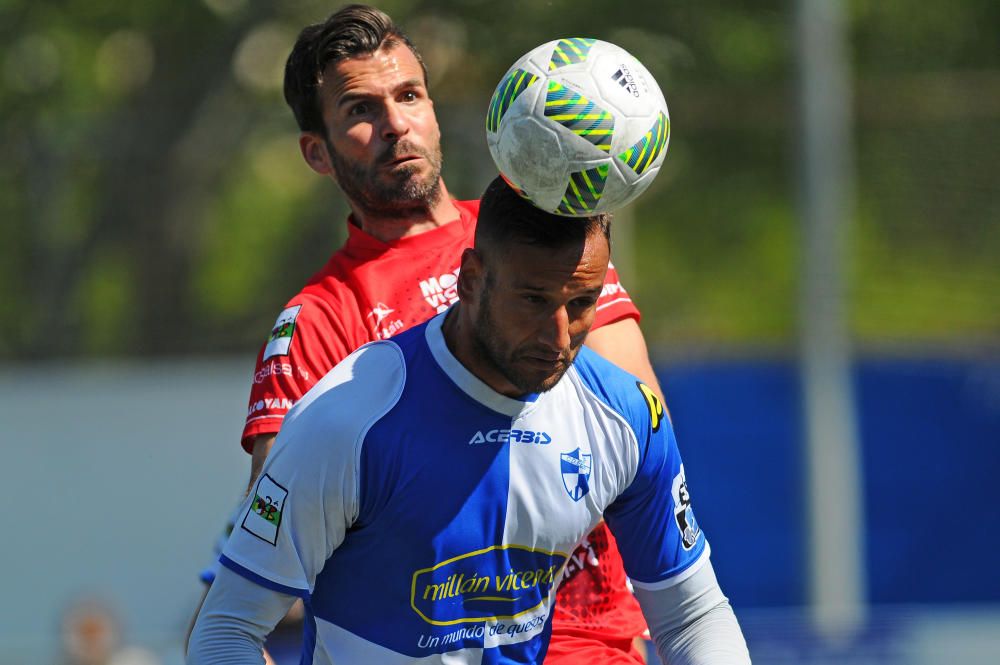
left=313, top=326, right=563, bottom=662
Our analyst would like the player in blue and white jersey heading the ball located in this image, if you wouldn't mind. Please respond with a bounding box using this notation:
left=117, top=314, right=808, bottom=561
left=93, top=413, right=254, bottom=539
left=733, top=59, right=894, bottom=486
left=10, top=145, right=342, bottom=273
left=189, top=179, right=749, bottom=665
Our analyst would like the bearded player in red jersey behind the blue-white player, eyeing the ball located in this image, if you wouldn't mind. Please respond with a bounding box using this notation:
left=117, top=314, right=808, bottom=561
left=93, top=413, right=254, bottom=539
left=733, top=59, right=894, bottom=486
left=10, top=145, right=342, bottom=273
left=195, top=5, right=659, bottom=664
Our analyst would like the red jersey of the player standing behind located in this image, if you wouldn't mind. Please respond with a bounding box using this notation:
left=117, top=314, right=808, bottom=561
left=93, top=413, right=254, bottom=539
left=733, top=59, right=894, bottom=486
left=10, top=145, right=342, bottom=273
left=242, top=201, right=646, bottom=663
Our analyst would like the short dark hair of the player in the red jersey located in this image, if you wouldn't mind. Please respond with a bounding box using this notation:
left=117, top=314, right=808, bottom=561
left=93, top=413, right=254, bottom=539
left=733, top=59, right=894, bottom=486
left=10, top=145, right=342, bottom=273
left=285, top=5, right=427, bottom=136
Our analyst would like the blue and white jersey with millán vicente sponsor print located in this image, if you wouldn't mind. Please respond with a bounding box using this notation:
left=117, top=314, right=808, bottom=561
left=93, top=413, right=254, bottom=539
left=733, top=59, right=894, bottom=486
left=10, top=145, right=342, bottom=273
left=221, top=314, right=708, bottom=664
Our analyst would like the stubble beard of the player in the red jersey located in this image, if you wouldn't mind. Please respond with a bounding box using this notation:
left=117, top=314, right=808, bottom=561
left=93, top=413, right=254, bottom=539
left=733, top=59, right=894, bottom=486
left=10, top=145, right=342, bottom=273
left=326, top=139, right=442, bottom=216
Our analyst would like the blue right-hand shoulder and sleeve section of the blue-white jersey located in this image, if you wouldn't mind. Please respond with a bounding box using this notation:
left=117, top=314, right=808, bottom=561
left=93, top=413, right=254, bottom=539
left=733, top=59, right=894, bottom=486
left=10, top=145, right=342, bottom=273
left=574, top=348, right=706, bottom=583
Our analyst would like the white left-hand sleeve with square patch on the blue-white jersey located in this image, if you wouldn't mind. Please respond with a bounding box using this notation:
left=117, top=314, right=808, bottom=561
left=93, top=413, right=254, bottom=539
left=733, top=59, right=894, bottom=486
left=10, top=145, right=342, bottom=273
left=220, top=342, right=405, bottom=598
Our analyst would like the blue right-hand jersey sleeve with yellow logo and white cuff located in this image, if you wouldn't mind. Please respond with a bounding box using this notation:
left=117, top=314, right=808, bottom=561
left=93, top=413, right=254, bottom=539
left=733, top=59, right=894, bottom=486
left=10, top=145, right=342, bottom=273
left=605, top=382, right=708, bottom=588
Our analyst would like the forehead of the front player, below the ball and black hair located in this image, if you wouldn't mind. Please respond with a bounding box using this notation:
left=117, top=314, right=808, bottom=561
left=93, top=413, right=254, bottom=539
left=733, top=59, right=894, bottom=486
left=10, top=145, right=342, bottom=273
left=491, top=231, right=610, bottom=291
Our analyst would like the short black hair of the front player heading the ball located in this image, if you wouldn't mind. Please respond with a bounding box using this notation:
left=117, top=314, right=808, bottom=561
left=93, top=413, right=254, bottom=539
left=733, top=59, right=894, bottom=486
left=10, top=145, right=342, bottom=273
left=475, top=177, right=611, bottom=254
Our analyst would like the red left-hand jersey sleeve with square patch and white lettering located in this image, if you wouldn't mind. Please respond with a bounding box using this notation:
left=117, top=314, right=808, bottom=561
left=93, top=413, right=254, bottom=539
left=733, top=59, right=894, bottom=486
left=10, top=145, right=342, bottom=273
left=241, top=296, right=367, bottom=452
